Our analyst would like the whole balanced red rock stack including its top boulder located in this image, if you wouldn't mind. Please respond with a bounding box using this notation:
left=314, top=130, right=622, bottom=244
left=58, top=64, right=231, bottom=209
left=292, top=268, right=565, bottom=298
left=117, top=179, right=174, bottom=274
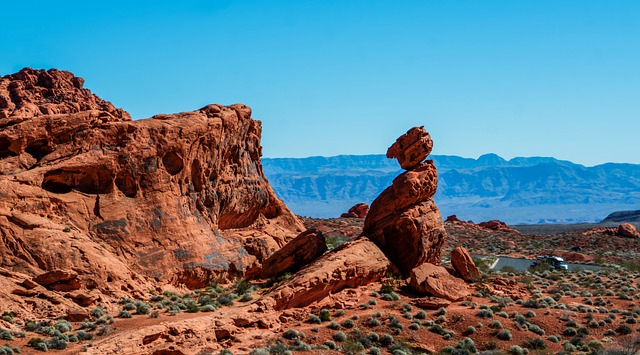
left=363, top=127, right=445, bottom=276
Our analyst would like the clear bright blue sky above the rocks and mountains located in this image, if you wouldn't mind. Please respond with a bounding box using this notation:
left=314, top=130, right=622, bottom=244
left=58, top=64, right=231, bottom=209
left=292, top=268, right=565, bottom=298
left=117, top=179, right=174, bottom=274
left=0, top=0, right=640, bottom=165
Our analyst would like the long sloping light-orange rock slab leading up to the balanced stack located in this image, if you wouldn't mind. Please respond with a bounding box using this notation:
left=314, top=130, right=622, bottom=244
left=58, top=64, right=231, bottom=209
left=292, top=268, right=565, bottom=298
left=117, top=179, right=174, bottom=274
left=265, top=237, right=394, bottom=310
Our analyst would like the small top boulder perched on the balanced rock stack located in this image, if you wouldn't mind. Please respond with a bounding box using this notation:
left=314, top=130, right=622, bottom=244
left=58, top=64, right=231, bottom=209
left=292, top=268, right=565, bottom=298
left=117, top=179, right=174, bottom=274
left=387, top=126, right=433, bottom=170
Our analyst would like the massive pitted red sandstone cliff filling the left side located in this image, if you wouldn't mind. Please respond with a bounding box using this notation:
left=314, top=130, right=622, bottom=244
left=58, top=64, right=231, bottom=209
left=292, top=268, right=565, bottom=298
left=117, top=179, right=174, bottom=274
left=0, top=69, right=303, bottom=316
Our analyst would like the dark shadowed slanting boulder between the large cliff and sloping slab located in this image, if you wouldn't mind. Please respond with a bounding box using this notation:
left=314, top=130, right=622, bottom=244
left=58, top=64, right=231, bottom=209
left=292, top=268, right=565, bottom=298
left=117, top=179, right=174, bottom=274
left=246, top=228, right=327, bottom=278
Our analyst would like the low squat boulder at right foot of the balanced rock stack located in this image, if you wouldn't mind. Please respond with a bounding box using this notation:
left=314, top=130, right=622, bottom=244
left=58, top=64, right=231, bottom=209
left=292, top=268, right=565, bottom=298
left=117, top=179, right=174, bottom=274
left=410, top=263, right=469, bottom=301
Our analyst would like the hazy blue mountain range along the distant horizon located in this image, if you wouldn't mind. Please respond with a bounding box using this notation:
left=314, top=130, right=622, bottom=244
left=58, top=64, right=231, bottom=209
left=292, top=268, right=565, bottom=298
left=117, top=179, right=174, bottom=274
left=262, top=154, right=640, bottom=224
